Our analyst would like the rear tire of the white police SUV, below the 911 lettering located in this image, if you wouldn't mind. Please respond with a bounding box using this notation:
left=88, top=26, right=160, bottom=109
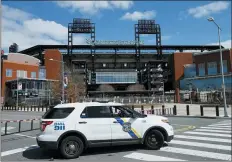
left=59, top=136, right=84, bottom=159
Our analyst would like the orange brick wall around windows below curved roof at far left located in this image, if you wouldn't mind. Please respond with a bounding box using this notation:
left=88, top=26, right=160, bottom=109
left=1, top=60, right=39, bottom=97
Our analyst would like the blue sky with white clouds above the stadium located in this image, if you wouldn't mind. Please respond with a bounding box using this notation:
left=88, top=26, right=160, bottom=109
left=1, top=1, right=231, bottom=53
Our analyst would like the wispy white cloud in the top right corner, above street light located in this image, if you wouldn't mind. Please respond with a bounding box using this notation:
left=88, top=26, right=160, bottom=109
left=188, top=1, right=230, bottom=18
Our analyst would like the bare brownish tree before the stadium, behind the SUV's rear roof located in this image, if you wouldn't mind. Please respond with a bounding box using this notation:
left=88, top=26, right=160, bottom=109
left=51, top=65, right=86, bottom=102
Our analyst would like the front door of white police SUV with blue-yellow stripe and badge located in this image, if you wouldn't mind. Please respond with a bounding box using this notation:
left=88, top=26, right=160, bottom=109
left=111, top=106, right=143, bottom=141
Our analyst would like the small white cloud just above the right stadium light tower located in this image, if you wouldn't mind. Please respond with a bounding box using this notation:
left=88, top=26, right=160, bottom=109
left=121, top=10, right=156, bottom=21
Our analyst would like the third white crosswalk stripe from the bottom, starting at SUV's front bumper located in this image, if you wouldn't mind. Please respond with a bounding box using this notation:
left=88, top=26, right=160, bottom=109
left=170, top=140, right=231, bottom=151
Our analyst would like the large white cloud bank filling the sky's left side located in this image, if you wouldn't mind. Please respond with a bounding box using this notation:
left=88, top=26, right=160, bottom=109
left=2, top=5, right=85, bottom=51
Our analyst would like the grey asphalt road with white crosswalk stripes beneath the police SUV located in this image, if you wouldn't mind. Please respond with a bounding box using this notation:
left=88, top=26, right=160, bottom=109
left=1, top=117, right=231, bottom=162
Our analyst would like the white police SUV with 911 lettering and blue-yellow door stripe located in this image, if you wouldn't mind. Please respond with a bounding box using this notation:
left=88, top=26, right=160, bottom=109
left=36, top=102, right=174, bottom=159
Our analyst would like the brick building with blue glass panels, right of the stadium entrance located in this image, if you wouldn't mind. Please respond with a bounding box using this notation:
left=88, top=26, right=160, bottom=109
left=173, top=49, right=232, bottom=102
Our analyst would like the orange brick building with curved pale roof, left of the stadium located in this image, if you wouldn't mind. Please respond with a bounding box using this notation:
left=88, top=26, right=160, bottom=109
left=1, top=50, right=61, bottom=105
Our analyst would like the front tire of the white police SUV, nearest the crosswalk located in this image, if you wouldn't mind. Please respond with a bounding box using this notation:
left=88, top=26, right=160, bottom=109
left=144, top=130, right=164, bottom=150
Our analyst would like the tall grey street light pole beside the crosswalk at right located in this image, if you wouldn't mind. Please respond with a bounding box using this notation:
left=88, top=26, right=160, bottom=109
left=207, top=17, right=228, bottom=117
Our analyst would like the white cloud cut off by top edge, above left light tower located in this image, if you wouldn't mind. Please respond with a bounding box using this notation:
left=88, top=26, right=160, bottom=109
left=55, top=1, right=133, bottom=15
